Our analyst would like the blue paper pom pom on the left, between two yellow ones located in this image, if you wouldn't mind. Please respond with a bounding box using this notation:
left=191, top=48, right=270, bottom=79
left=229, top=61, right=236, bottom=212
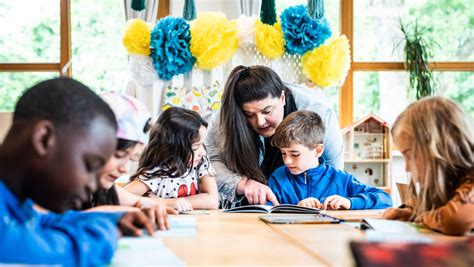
left=150, top=17, right=196, bottom=81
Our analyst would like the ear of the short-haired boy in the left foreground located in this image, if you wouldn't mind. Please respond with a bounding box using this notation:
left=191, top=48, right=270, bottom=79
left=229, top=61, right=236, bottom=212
left=31, top=120, right=56, bottom=157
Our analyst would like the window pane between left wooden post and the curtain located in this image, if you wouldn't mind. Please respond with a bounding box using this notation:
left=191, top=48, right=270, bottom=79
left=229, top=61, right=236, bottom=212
left=71, top=0, right=128, bottom=92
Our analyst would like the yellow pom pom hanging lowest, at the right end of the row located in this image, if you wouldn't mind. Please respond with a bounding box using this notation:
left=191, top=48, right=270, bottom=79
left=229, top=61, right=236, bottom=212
left=301, top=35, right=350, bottom=88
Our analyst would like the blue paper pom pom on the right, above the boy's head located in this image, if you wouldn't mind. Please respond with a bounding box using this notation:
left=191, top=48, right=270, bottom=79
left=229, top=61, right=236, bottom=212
left=280, top=5, right=331, bottom=55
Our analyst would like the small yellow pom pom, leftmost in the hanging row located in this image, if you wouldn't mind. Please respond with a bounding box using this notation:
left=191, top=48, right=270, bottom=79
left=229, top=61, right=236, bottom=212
left=122, top=19, right=151, bottom=56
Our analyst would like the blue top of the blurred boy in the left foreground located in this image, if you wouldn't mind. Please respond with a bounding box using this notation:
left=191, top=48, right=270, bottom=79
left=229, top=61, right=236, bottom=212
left=0, top=181, right=122, bottom=266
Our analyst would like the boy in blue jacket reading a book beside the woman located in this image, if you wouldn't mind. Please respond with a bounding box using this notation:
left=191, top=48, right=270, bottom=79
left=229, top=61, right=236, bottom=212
left=268, top=110, right=392, bottom=209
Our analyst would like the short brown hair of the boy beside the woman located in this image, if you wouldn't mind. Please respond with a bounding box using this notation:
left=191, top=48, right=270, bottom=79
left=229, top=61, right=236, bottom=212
left=272, top=110, right=326, bottom=148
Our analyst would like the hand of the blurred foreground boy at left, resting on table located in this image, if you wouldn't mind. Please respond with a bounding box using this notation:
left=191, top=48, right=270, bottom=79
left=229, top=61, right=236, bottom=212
left=117, top=211, right=154, bottom=236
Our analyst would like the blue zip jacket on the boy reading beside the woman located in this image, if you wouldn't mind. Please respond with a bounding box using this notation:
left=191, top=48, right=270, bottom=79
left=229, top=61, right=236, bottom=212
left=268, top=162, right=392, bottom=210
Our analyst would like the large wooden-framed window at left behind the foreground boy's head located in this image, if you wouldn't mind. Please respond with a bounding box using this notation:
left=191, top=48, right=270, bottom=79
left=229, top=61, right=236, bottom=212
left=0, top=0, right=128, bottom=112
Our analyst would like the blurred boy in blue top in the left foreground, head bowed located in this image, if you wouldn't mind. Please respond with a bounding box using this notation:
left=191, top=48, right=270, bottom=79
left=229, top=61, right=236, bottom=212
left=0, top=78, right=153, bottom=266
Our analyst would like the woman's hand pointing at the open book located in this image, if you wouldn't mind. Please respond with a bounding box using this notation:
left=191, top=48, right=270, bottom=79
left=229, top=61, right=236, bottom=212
left=237, top=177, right=280, bottom=206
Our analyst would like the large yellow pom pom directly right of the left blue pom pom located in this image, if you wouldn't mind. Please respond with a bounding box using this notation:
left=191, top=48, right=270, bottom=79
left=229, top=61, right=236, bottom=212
left=190, top=12, right=239, bottom=70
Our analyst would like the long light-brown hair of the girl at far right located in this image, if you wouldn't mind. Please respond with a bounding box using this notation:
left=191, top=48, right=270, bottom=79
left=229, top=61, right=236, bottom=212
left=392, top=97, right=474, bottom=218
